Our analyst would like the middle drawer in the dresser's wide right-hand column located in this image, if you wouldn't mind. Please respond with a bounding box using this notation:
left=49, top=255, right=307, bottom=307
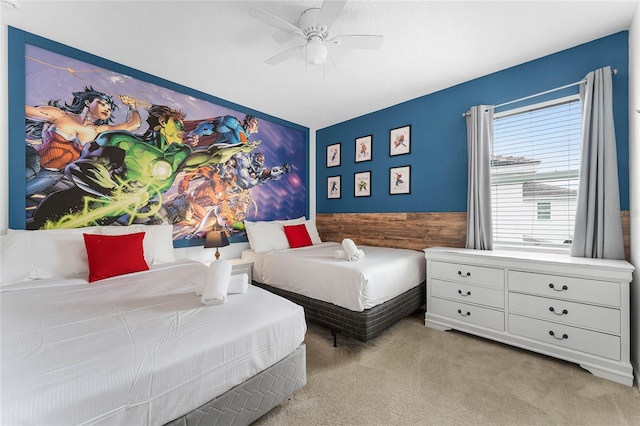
left=509, top=293, right=620, bottom=334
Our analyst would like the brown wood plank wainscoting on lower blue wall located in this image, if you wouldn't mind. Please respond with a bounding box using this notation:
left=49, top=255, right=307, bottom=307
left=316, top=210, right=631, bottom=260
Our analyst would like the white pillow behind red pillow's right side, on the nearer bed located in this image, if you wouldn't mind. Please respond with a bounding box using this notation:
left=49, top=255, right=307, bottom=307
left=96, top=225, right=176, bottom=265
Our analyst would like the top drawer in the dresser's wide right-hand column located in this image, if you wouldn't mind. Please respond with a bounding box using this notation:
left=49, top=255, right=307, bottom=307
left=509, top=271, right=620, bottom=306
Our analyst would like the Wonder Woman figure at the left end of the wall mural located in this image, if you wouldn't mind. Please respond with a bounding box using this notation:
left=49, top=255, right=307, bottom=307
left=25, top=87, right=141, bottom=196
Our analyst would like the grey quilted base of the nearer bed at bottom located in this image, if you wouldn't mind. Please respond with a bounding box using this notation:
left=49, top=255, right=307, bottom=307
left=166, top=343, right=307, bottom=426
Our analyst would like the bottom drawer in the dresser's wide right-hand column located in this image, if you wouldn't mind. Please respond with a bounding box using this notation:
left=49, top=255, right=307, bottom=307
left=509, top=314, right=620, bottom=360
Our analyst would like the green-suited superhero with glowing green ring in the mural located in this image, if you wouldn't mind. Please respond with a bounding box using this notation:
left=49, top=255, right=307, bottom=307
left=29, top=105, right=260, bottom=229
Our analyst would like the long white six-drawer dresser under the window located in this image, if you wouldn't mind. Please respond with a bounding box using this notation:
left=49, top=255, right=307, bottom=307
left=424, top=247, right=633, bottom=386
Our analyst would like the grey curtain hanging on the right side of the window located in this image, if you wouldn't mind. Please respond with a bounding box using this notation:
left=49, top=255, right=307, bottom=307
left=571, top=67, right=624, bottom=259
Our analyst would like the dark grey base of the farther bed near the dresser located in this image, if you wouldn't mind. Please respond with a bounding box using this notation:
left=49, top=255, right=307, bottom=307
left=253, top=281, right=426, bottom=346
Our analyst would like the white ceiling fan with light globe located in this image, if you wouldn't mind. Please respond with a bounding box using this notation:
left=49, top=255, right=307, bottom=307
left=249, top=0, right=383, bottom=65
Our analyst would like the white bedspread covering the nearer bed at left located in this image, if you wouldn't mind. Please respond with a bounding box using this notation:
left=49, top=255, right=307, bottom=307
left=0, top=261, right=306, bottom=425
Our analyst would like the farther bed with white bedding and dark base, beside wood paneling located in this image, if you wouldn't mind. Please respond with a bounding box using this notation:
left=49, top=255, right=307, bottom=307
left=242, top=218, right=426, bottom=345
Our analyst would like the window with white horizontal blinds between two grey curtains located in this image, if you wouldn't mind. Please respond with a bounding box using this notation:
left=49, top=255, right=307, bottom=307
left=491, top=95, right=581, bottom=250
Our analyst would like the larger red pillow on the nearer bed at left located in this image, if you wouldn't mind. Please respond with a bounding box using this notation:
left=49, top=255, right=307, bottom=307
left=82, top=232, right=149, bottom=283
